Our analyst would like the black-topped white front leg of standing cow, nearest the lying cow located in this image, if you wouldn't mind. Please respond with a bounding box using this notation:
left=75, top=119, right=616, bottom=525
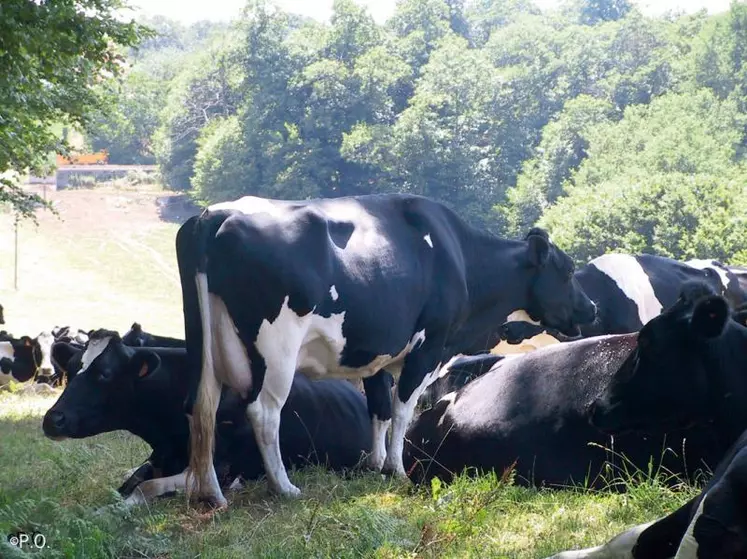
left=382, top=338, right=443, bottom=478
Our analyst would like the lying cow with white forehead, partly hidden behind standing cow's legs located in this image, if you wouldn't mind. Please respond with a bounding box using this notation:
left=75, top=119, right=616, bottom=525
left=42, top=330, right=372, bottom=503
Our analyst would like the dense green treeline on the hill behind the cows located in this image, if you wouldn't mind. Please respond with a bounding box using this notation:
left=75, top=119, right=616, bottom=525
left=89, top=0, right=747, bottom=263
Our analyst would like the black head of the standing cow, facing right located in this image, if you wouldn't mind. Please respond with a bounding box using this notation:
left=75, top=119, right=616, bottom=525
left=525, top=227, right=596, bottom=336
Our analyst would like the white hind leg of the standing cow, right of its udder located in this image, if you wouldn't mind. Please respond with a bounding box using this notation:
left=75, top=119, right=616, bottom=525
left=246, top=359, right=301, bottom=497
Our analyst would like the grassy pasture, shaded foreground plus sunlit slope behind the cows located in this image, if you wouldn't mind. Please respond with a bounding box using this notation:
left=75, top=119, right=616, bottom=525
left=0, top=188, right=697, bottom=559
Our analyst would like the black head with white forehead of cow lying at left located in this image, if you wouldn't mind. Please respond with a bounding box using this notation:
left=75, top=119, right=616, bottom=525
left=42, top=330, right=160, bottom=440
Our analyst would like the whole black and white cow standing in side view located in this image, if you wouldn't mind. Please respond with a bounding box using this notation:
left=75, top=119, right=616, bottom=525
left=176, top=194, right=595, bottom=506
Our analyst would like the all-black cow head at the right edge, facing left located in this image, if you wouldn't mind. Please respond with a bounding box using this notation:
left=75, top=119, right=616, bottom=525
left=590, top=282, right=747, bottom=433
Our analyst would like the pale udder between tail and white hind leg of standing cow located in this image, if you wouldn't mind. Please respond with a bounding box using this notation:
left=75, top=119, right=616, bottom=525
left=208, top=293, right=252, bottom=397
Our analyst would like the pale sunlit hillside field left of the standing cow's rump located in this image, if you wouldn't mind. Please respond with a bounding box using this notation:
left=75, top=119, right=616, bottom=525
left=0, top=187, right=195, bottom=337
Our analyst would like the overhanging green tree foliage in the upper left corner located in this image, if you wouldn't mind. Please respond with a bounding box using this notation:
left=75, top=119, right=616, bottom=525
left=0, top=0, right=149, bottom=217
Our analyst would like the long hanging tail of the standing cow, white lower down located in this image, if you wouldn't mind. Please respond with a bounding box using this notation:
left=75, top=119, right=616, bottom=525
left=187, top=211, right=221, bottom=504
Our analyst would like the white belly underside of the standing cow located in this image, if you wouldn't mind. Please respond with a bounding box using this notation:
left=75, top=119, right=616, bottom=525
left=296, top=312, right=425, bottom=379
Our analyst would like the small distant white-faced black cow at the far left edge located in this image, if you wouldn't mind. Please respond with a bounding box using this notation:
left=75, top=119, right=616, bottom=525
left=0, top=332, right=54, bottom=386
